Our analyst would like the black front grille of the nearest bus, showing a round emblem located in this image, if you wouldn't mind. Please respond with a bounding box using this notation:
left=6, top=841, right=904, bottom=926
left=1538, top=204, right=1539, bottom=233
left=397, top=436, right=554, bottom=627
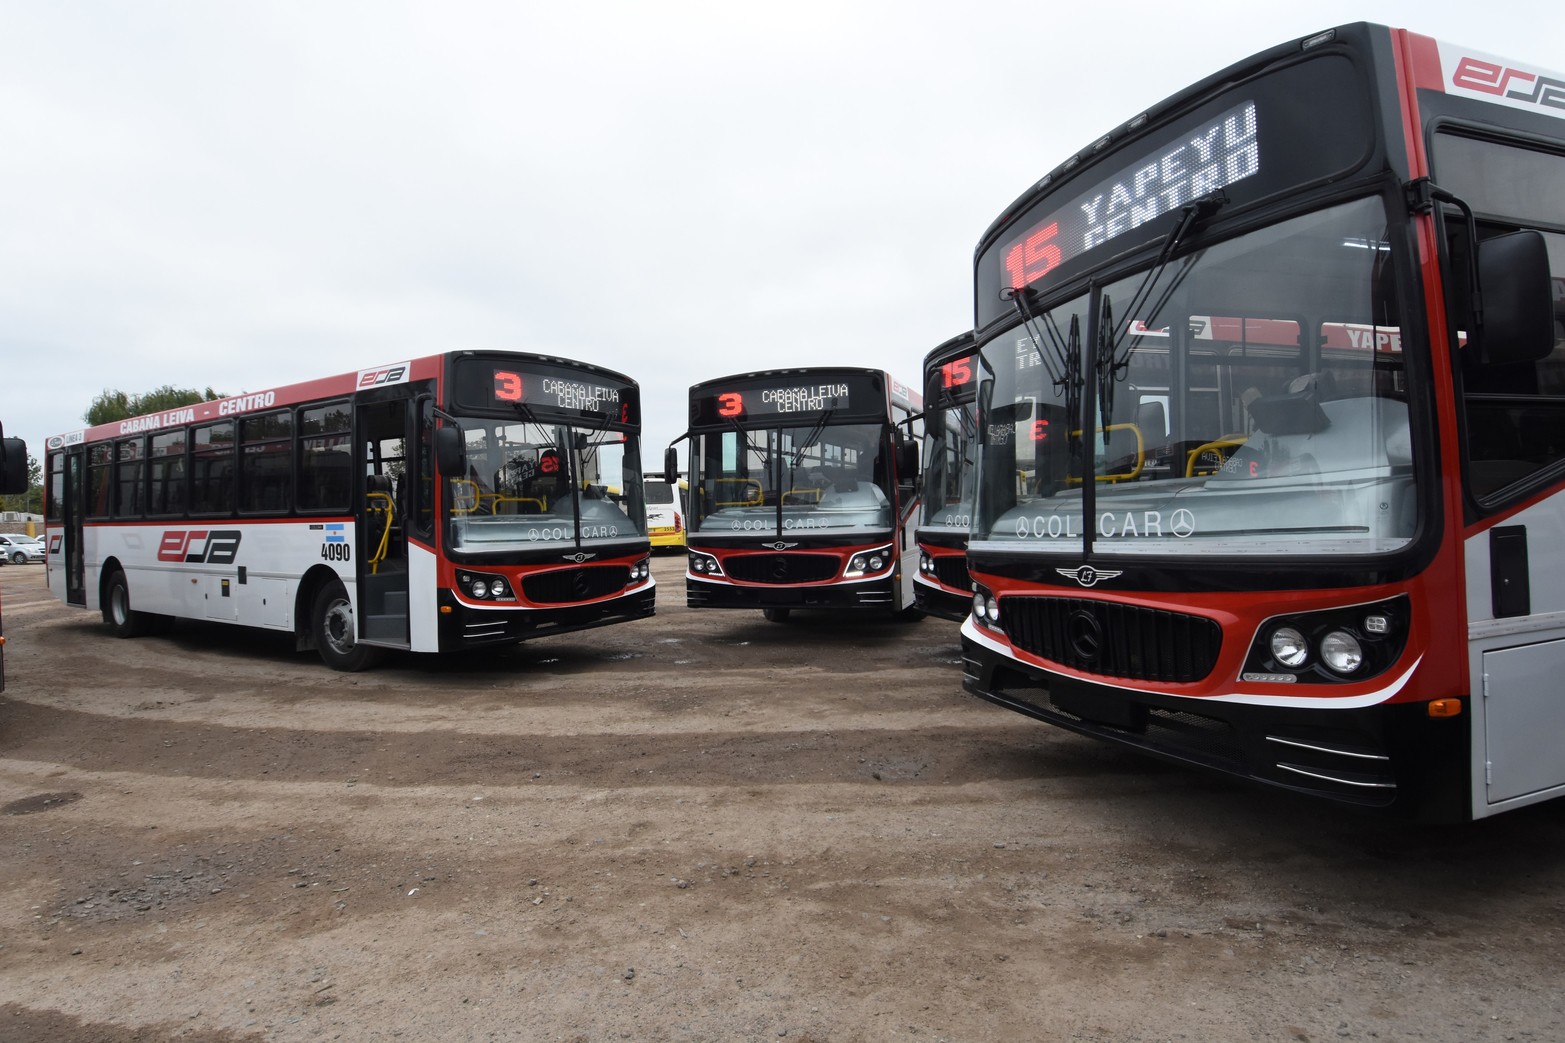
left=1000, top=597, right=1222, bottom=683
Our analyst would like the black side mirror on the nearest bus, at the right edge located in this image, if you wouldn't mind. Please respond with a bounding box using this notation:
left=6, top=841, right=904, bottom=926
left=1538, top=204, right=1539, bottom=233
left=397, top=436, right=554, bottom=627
left=1476, top=232, right=1554, bottom=366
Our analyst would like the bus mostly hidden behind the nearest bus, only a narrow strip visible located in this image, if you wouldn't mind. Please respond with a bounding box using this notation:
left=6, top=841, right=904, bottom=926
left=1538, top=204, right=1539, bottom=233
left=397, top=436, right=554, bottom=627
left=912, top=332, right=978, bottom=622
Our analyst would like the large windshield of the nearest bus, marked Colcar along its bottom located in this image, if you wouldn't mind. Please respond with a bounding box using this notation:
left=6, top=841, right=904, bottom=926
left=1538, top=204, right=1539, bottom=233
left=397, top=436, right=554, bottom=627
left=972, top=192, right=1418, bottom=554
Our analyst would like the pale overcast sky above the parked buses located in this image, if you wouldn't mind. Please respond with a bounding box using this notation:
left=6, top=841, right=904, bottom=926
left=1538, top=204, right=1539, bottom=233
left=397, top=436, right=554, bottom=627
left=0, top=0, right=1565, bottom=467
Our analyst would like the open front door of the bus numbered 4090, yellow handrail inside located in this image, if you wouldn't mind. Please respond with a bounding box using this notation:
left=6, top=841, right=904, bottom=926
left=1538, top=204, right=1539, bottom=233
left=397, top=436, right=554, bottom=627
left=354, top=396, right=416, bottom=648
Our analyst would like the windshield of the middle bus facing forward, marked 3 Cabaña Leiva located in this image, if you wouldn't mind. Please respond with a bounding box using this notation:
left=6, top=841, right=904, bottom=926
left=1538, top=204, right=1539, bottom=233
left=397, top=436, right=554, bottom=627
left=690, top=423, right=895, bottom=536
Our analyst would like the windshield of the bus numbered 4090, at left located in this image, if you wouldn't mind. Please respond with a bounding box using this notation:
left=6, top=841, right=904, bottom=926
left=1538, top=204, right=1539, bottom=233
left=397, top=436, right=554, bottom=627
left=444, top=418, right=646, bottom=551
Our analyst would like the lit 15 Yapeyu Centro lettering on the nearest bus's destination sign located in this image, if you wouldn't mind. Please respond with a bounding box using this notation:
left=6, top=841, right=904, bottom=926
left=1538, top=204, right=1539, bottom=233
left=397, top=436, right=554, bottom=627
left=1002, top=102, right=1261, bottom=288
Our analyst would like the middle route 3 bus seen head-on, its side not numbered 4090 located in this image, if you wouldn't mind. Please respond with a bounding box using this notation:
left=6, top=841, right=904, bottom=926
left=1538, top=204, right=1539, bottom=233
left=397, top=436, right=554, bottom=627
left=665, top=366, right=920, bottom=622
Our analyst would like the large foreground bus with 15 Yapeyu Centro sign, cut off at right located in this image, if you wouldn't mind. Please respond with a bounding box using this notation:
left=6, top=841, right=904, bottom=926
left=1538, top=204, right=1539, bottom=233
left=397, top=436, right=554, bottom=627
left=962, top=23, right=1565, bottom=821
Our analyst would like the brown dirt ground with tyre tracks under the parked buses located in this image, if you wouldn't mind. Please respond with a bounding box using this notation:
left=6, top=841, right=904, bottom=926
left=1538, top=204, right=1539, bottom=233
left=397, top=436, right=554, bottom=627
left=0, top=558, right=1565, bottom=1043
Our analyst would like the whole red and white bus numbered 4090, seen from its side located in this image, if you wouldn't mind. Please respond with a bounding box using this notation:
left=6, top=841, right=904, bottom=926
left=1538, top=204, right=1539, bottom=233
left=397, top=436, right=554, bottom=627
left=45, top=351, right=654, bottom=670
